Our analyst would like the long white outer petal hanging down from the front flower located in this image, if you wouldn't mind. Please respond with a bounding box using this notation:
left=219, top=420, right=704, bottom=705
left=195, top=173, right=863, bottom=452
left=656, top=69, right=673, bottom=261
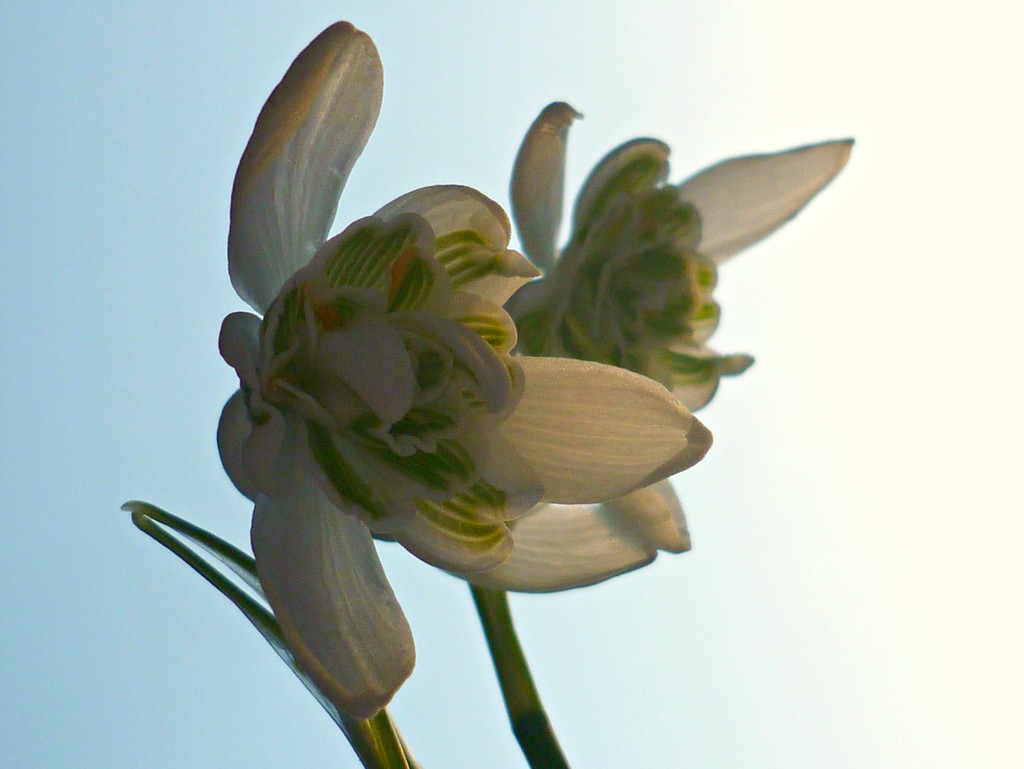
left=252, top=475, right=416, bottom=719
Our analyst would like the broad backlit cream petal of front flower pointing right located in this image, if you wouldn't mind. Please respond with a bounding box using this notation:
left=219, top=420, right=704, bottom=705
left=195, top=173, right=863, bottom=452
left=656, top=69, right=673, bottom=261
left=500, top=357, right=712, bottom=504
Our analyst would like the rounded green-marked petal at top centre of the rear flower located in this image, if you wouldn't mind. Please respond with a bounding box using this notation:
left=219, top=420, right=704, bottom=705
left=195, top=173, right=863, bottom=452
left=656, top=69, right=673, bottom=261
left=572, top=139, right=670, bottom=238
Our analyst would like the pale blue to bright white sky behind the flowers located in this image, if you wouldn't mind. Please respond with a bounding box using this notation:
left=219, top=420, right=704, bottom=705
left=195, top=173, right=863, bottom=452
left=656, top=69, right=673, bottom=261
left=0, top=0, right=1024, bottom=769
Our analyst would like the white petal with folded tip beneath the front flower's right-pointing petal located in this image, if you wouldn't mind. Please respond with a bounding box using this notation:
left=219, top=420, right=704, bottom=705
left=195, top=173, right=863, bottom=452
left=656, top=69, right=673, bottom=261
left=464, top=480, right=690, bottom=593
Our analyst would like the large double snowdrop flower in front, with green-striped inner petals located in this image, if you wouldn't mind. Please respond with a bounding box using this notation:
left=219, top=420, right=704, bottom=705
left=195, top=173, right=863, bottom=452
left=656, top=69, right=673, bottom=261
left=218, top=24, right=711, bottom=718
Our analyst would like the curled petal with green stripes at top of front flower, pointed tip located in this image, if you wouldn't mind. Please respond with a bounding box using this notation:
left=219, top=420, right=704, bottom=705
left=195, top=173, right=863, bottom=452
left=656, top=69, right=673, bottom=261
left=375, top=184, right=541, bottom=305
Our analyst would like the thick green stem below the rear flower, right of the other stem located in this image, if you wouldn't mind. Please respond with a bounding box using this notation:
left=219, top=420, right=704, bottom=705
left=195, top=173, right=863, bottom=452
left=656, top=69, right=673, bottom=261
left=470, top=586, right=569, bottom=769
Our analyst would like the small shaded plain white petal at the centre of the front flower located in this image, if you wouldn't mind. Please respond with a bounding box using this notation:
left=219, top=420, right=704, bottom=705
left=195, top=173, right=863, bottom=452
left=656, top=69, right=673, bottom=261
left=316, top=318, right=416, bottom=425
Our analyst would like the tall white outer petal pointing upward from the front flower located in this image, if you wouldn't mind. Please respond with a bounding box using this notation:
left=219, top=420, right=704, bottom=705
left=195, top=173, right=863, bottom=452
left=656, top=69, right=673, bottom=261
left=227, top=24, right=383, bottom=312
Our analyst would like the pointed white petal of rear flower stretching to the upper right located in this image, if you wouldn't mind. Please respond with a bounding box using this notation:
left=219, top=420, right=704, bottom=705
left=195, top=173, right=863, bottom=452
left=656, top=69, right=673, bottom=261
left=679, top=139, right=853, bottom=263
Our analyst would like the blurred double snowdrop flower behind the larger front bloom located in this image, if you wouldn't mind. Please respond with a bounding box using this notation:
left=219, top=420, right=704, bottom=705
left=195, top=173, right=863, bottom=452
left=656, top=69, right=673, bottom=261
left=474, top=102, right=852, bottom=591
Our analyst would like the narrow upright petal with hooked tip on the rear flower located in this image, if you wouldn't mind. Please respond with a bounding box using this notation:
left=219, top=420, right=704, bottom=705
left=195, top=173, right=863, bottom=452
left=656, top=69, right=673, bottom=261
left=509, top=101, right=583, bottom=270
